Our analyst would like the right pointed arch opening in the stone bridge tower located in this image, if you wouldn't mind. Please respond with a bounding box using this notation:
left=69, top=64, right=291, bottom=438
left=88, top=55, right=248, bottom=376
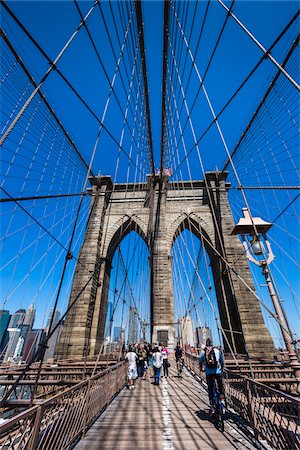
left=171, top=215, right=245, bottom=354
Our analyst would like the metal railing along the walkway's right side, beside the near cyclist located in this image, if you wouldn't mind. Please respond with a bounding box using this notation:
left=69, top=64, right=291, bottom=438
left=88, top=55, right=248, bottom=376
left=185, top=353, right=300, bottom=450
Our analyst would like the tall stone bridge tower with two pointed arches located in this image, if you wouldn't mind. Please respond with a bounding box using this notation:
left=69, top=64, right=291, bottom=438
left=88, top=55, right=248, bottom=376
left=56, top=172, right=275, bottom=359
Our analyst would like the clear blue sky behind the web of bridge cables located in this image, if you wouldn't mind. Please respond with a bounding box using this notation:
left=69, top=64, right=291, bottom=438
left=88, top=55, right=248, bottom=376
left=1, top=0, right=299, bottom=348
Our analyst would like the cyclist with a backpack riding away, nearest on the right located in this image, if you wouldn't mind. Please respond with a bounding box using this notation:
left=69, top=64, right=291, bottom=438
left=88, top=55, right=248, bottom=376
left=199, top=338, right=224, bottom=415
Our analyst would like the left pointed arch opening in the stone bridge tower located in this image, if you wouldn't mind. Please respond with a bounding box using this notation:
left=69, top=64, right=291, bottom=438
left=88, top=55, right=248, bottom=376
left=101, top=218, right=150, bottom=352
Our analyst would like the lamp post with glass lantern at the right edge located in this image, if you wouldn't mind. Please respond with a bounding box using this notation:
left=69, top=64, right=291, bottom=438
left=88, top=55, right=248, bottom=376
left=232, top=208, right=300, bottom=378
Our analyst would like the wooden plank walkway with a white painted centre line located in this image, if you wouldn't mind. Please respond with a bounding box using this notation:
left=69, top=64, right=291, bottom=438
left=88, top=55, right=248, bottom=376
left=76, top=367, right=257, bottom=450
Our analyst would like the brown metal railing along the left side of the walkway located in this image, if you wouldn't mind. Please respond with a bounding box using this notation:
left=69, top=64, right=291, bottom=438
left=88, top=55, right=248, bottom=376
left=0, top=362, right=126, bottom=450
